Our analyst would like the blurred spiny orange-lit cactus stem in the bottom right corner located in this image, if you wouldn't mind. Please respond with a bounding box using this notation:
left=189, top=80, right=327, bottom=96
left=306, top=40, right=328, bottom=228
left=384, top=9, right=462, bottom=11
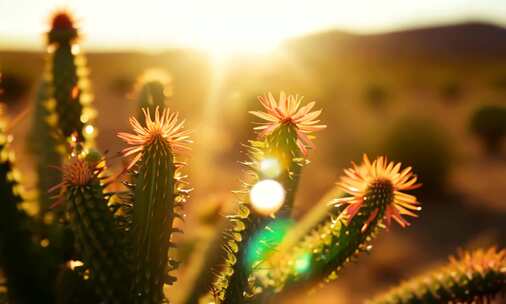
left=367, top=248, right=506, bottom=304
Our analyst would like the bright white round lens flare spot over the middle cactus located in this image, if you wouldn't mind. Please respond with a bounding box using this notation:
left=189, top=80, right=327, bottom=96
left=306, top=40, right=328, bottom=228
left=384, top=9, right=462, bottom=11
left=250, top=179, right=285, bottom=215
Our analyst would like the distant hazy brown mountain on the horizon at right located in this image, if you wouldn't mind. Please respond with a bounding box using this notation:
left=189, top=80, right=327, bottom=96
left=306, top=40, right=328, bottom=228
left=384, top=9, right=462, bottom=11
left=286, top=23, right=506, bottom=58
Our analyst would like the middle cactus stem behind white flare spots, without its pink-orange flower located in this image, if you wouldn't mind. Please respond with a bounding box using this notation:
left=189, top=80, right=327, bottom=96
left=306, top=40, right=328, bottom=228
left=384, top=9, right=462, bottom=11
left=214, top=132, right=300, bottom=303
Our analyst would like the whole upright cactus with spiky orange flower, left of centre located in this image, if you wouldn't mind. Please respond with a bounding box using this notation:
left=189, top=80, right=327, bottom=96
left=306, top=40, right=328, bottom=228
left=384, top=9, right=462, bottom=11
left=118, top=108, right=191, bottom=304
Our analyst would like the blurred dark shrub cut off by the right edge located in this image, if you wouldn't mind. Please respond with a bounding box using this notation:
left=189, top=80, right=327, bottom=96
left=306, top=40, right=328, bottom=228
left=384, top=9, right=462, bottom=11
left=470, top=105, right=506, bottom=154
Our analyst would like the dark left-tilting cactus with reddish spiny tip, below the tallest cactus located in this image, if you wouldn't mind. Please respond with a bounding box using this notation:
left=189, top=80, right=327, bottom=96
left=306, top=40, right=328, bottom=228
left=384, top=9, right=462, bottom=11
left=56, top=152, right=131, bottom=303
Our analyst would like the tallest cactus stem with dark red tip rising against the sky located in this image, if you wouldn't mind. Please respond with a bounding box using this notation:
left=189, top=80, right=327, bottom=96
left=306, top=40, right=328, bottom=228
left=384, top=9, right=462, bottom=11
left=45, top=12, right=96, bottom=142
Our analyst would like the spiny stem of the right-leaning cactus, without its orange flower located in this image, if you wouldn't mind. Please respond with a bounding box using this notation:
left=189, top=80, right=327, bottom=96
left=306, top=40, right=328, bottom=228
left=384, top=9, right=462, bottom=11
left=255, top=185, right=385, bottom=292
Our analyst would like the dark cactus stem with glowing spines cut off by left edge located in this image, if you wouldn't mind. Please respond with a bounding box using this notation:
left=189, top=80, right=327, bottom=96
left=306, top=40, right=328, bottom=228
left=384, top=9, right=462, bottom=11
left=0, top=109, right=56, bottom=303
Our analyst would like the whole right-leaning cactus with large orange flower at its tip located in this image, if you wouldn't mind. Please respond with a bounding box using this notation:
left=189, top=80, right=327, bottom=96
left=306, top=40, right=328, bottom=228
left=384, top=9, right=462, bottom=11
left=255, top=155, right=421, bottom=291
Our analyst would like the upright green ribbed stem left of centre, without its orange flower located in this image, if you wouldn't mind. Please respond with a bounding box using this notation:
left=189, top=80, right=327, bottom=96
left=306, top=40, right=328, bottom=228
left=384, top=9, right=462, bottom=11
left=128, top=142, right=180, bottom=303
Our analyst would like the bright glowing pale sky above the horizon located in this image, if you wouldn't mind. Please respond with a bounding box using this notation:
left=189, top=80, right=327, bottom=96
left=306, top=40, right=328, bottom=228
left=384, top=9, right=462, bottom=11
left=0, top=0, right=506, bottom=49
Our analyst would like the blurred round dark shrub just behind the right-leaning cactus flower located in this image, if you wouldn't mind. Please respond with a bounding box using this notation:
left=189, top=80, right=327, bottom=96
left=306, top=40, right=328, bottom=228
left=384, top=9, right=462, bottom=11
left=383, top=117, right=453, bottom=194
